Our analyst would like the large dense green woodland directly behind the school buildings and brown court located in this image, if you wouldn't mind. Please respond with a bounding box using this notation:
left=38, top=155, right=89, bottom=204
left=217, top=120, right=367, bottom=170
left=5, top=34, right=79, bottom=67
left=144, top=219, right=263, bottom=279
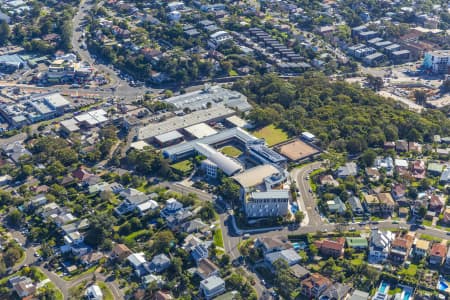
left=234, top=73, right=450, bottom=153
